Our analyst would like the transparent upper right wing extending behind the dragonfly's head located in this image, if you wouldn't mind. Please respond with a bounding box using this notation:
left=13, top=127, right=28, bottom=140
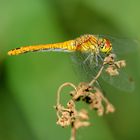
left=99, top=35, right=140, bottom=55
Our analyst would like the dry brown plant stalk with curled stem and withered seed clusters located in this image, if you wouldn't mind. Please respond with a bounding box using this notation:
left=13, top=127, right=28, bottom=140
left=55, top=54, right=126, bottom=140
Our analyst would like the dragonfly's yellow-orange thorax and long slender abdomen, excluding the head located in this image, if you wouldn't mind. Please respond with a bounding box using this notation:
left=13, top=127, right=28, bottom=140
left=8, top=35, right=97, bottom=55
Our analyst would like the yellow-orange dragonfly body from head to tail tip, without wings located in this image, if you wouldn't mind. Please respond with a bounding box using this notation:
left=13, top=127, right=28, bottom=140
left=8, top=35, right=112, bottom=55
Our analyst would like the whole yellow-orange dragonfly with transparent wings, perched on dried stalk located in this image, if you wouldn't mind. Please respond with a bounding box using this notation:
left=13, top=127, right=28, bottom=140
left=8, top=34, right=138, bottom=92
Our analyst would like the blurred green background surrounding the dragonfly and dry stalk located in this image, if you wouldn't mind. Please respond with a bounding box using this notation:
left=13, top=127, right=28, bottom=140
left=0, top=0, right=140, bottom=140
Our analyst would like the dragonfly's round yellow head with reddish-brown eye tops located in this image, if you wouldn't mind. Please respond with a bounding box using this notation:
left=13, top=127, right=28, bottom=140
left=98, top=38, right=112, bottom=53
